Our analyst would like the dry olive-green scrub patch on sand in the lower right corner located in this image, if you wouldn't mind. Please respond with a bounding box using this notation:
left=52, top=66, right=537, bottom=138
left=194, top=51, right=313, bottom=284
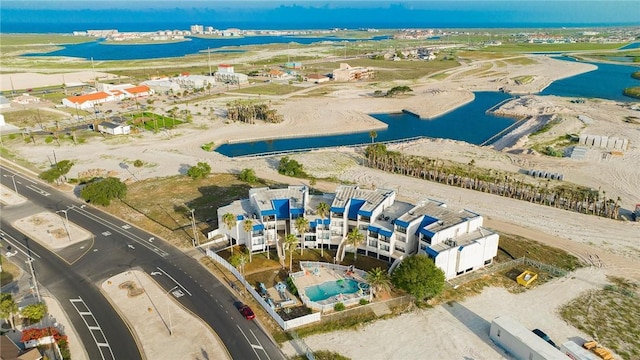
left=560, top=277, right=640, bottom=360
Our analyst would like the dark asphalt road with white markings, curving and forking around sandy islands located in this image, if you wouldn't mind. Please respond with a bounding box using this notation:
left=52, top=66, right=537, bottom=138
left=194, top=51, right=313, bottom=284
left=0, top=167, right=284, bottom=360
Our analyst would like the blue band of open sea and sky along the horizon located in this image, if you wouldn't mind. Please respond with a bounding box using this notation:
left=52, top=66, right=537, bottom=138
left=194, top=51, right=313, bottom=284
left=0, top=0, right=640, bottom=34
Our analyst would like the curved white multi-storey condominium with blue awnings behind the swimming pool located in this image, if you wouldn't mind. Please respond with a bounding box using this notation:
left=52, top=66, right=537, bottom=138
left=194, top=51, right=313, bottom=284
left=209, top=185, right=498, bottom=279
